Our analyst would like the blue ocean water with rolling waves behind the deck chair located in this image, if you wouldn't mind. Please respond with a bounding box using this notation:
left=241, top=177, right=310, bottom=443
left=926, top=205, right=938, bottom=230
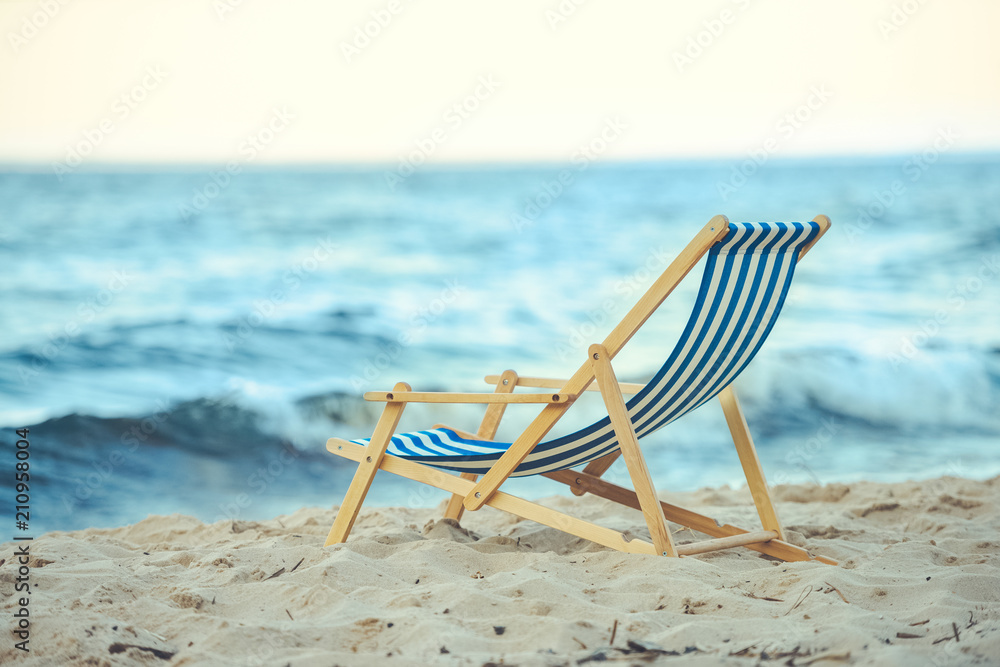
left=0, top=154, right=1000, bottom=531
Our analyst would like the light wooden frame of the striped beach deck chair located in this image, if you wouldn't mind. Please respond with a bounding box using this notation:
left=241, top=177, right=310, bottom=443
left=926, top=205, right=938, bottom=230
left=326, top=215, right=836, bottom=565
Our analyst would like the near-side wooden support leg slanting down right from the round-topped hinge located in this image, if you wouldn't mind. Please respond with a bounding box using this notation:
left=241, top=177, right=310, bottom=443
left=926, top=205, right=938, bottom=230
left=590, top=345, right=677, bottom=556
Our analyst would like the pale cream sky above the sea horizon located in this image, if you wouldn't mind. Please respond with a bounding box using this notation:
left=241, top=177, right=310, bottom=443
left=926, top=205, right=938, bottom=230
left=0, top=0, right=1000, bottom=165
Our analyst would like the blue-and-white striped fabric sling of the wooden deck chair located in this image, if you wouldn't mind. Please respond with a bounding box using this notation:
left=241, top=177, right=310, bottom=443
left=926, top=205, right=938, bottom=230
left=352, top=222, right=820, bottom=477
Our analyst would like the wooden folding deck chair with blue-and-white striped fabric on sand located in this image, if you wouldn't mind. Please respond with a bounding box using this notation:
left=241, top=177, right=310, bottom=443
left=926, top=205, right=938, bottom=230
left=326, top=215, right=836, bottom=564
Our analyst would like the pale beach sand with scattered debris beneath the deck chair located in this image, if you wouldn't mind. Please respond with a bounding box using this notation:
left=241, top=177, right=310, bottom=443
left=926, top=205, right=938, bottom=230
left=0, top=478, right=1000, bottom=667
